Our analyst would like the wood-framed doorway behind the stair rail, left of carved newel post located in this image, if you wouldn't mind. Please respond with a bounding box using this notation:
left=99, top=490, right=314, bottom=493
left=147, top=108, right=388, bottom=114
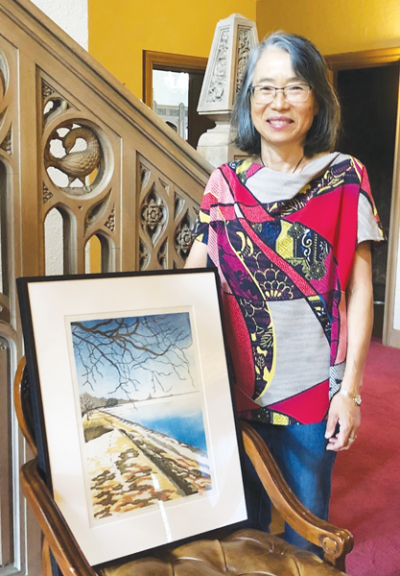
left=143, top=50, right=215, bottom=148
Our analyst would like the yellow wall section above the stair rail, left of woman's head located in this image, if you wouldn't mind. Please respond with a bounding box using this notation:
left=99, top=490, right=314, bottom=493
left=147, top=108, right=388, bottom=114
left=88, top=0, right=256, bottom=98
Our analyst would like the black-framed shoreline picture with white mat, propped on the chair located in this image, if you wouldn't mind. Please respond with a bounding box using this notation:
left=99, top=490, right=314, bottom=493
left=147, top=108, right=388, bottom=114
left=17, top=269, right=247, bottom=565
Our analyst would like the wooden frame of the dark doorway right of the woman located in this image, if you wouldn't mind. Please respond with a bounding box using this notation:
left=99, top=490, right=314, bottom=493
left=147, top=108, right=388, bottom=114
left=325, top=47, right=400, bottom=348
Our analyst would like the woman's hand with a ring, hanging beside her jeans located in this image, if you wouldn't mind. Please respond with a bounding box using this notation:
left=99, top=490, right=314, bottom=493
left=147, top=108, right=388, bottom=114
left=325, top=393, right=361, bottom=452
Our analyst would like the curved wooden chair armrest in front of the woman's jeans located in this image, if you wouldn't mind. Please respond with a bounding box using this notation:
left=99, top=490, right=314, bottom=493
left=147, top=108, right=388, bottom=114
left=240, top=420, right=354, bottom=572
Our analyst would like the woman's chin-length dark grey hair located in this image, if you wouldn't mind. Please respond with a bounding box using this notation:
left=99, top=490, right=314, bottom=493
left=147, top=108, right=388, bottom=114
left=231, top=32, right=340, bottom=158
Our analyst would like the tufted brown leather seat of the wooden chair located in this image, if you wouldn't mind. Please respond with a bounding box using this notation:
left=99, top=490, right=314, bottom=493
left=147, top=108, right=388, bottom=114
left=99, top=529, right=344, bottom=576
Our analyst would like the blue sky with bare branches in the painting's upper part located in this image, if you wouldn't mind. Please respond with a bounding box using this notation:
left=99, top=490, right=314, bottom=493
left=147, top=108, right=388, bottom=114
left=71, top=312, right=198, bottom=401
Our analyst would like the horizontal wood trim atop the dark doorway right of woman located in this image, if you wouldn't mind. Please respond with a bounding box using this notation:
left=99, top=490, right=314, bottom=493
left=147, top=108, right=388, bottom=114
left=325, top=46, right=400, bottom=71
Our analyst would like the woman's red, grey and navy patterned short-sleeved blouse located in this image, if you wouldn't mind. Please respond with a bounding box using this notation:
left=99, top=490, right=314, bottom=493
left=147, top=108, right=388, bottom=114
left=194, top=153, right=383, bottom=424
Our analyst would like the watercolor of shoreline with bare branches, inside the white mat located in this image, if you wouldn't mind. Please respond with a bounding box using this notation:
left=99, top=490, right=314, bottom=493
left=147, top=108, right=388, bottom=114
left=70, top=312, right=212, bottom=520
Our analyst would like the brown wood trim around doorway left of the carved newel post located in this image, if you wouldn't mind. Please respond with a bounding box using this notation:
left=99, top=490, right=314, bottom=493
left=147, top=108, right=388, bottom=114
left=143, top=50, right=208, bottom=108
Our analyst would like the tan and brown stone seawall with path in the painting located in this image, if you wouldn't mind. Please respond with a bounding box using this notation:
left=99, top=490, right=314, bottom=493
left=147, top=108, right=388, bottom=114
left=83, top=410, right=211, bottom=519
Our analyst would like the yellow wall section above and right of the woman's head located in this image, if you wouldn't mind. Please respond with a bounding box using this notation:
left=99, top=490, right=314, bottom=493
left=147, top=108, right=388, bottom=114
left=256, top=0, right=400, bottom=54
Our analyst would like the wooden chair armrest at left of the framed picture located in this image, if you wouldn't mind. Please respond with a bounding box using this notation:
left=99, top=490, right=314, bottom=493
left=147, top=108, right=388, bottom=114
left=20, top=459, right=97, bottom=576
